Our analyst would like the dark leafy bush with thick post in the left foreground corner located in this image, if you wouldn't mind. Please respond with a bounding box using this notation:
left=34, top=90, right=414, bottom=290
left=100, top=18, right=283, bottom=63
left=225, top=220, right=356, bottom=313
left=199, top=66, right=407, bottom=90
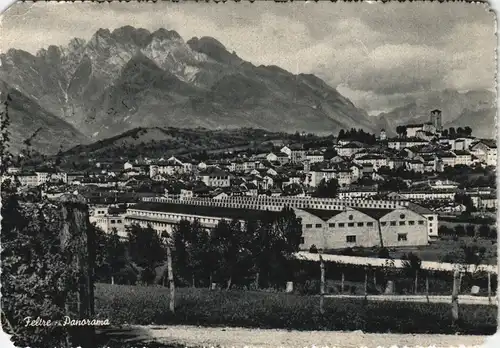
left=1, top=191, right=96, bottom=348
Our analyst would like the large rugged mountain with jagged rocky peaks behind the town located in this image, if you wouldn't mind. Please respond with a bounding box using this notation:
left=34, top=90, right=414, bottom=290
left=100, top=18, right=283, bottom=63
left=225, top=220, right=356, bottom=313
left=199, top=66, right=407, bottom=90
left=0, top=26, right=374, bottom=150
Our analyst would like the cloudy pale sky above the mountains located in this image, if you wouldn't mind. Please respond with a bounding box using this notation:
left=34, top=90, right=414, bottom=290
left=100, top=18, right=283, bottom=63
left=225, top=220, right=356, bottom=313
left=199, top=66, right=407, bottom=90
left=0, top=1, right=497, bottom=113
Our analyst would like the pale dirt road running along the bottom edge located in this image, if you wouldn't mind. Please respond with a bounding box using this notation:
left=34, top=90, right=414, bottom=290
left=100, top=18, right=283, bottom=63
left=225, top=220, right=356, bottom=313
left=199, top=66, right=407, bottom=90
left=114, top=326, right=498, bottom=348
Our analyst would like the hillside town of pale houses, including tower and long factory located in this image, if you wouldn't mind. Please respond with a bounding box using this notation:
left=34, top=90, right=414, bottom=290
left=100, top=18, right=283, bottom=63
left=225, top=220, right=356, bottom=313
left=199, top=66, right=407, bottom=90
left=2, top=110, right=497, bottom=250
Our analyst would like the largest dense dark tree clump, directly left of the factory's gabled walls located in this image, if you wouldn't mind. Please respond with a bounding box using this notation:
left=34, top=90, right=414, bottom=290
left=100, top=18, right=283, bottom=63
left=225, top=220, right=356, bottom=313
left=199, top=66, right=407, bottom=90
left=173, top=208, right=302, bottom=288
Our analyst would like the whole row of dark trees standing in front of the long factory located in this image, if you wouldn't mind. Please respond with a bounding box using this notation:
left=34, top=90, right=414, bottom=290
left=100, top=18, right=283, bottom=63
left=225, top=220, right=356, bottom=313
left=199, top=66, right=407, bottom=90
left=96, top=208, right=302, bottom=289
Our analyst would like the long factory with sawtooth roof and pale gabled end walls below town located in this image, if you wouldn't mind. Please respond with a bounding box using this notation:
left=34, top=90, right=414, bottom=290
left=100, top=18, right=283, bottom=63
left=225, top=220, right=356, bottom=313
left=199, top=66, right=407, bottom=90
left=125, top=196, right=438, bottom=250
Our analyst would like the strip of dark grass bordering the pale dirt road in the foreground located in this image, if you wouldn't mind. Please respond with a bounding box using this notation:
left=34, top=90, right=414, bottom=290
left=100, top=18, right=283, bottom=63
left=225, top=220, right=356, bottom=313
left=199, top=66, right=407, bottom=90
left=95, top=284, right=497, bottom=335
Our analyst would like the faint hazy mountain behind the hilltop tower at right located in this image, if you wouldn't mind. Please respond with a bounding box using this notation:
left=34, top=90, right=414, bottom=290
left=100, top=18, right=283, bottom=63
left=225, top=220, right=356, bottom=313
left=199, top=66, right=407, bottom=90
left=372, top=89, right=496, bottom=138
